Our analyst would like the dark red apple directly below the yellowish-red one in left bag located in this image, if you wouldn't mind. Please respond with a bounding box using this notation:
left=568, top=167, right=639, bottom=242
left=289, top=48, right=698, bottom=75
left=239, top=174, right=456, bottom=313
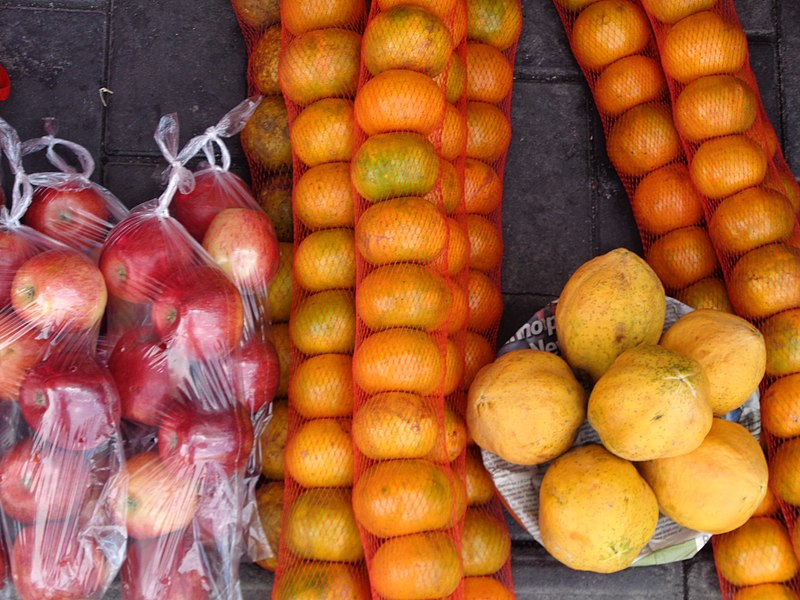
left=20, top=357, right=120, bottom=451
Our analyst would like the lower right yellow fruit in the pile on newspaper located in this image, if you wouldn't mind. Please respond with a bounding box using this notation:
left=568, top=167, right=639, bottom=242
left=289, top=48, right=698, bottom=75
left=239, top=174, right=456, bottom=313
left=639, top=419, right=768, bottom=533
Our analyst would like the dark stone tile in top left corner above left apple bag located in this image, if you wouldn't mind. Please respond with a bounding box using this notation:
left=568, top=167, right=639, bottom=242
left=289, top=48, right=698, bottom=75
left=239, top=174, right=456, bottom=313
left=0, top=7, right=106, bottom=162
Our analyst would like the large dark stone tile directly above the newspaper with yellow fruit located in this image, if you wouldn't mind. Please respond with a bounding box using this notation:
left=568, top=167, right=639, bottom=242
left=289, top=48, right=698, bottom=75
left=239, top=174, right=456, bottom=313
left=502, top=81, right=592, bottom=296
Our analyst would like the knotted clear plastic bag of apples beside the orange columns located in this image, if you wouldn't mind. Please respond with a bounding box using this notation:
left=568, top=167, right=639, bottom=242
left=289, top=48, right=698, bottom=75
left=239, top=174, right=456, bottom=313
left=100, top=101, right=279, bottom=600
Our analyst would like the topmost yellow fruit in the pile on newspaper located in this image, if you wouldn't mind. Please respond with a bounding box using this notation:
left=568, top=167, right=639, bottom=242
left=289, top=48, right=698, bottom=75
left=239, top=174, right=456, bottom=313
left=556, top=248, right=667, bottom=380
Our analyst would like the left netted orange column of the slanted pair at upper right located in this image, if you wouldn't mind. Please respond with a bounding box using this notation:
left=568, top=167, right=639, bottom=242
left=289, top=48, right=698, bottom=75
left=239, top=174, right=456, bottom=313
left=555, top=0, right=732, bottom=312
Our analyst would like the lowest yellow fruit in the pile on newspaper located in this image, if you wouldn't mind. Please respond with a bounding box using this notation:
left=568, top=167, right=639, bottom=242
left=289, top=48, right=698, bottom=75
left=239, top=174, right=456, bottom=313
left=539, top=444, right=658, bottom=573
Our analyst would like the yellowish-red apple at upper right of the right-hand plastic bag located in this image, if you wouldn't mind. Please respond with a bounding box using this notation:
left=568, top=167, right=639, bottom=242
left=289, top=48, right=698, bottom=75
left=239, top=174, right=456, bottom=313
left=203, top=208, right=280, bottom=291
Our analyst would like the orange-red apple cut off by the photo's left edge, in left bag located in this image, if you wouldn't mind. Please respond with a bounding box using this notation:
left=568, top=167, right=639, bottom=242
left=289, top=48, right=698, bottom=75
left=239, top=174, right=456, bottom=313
left=0, top=313, right=45, bottom=400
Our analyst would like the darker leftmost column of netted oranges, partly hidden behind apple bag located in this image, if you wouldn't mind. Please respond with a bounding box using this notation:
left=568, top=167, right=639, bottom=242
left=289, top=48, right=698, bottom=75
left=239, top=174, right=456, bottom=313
left=232, top=0, right=294, bottom=570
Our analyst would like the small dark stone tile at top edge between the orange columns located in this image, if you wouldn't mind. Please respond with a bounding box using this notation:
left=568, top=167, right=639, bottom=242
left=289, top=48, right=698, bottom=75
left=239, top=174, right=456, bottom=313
left=516, top=0, right=582, bottom=79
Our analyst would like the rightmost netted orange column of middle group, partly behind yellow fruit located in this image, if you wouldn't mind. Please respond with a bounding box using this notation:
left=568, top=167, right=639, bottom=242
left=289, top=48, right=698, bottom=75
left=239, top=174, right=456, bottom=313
left=456, top=0, right=522, bottom=597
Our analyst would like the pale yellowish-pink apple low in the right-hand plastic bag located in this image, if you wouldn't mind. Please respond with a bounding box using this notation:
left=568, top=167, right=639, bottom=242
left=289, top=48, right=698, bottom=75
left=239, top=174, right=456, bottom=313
left=110, top=452, right=198, bottom=539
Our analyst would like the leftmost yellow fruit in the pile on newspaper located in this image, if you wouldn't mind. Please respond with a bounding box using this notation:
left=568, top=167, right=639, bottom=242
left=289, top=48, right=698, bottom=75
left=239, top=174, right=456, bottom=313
left=467, top=350, right=586, bottom=465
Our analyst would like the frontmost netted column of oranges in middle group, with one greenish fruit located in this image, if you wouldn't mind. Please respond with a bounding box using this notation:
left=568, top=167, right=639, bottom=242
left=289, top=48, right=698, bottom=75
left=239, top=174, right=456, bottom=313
left=351, top=0, right=476, bottom=599
